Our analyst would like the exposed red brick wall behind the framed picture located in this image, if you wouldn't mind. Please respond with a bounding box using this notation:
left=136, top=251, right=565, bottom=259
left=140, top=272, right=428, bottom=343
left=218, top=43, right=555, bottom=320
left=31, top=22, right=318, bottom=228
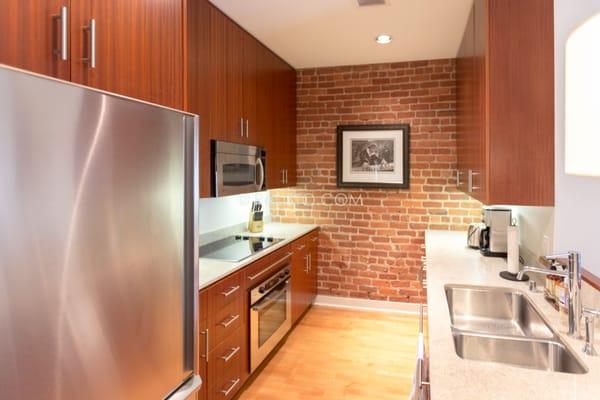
left=271, top=60, right=481, bottom=302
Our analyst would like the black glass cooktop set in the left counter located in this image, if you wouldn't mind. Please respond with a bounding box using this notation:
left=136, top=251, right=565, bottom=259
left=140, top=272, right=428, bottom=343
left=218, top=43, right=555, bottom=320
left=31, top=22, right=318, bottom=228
left=199, top=235, right=283, bottom=262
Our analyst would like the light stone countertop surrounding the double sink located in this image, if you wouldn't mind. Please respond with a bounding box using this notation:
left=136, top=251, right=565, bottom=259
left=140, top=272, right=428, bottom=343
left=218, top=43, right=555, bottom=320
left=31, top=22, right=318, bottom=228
left=425, top=231, right=600, bottom=400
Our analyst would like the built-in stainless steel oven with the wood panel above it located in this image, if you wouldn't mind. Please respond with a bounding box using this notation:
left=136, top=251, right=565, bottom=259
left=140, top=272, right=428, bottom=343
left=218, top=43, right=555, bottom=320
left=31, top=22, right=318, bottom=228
left=249, top=254, right=292, bottom=372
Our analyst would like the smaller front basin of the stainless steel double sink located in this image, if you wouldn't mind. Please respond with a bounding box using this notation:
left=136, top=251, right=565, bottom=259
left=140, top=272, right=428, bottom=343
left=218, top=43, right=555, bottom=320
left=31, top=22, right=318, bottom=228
left=453, top=331, right=587, bottom=374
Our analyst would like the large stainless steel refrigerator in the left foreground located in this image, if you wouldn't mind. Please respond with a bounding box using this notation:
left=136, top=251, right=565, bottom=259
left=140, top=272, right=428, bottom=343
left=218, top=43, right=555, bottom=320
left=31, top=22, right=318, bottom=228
left=0, top=66, right=201, bottom=400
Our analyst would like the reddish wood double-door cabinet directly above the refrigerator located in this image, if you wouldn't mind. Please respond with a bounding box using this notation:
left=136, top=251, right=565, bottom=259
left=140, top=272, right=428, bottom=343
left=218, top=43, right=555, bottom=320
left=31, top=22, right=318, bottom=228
left=0, top=0, right=183, bottom=108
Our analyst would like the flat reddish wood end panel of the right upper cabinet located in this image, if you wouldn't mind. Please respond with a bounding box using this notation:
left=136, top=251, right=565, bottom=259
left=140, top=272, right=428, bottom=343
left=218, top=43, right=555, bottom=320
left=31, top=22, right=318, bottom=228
left=487, top=0, right=554, bottom=206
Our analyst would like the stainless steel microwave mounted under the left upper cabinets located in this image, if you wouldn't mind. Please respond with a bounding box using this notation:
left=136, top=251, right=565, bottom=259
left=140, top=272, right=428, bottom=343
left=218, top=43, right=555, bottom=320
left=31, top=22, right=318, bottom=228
left=212, top=141, right=265, bottom=197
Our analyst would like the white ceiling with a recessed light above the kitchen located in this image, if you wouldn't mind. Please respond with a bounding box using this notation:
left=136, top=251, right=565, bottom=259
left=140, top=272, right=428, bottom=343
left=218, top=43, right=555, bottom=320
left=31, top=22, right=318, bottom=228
left=206, top=0, right=473, bottom=68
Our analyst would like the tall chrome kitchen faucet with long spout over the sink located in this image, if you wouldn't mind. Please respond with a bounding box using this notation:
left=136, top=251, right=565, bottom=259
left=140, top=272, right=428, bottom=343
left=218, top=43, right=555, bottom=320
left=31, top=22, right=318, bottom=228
left=517, top=251, right=583, bottom=339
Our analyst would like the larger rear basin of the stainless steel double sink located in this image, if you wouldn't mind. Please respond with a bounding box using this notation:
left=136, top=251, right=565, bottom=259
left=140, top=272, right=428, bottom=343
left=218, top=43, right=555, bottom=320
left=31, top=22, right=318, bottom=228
left=445, top=285, right=555, bottom=339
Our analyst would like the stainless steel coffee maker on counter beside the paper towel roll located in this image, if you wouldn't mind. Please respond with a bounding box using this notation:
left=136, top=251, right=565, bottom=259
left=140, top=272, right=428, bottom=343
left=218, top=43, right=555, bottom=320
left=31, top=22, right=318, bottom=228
left=479, top=207, right=512, bottom=257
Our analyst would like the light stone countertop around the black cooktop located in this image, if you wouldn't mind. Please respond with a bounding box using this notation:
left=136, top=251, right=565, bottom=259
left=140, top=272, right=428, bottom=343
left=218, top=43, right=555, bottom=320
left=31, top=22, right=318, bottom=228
left=198, top=222, right=319, bottom=290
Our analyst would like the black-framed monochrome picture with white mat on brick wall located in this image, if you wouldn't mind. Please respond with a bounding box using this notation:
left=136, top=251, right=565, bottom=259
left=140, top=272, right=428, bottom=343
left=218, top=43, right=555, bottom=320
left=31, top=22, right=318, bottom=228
left=337, top=124, right=410, bottom=189
